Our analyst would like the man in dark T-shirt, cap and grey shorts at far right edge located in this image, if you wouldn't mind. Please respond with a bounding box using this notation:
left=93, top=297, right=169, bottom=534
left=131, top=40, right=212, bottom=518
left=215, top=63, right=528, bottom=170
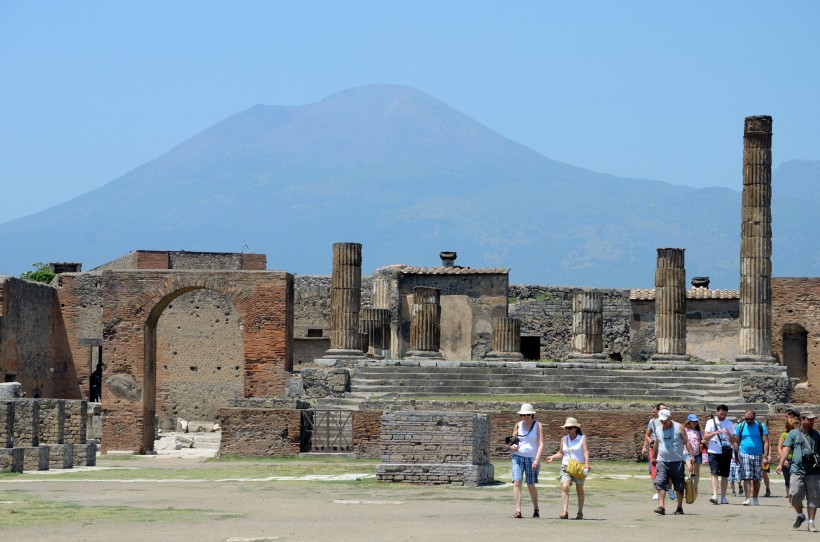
left=777, top=412, right=820, bottom=533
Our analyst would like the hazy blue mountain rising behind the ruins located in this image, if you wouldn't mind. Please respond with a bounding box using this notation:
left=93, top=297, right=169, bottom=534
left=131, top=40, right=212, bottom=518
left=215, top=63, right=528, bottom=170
left=0, top=85, right=820, bottom=288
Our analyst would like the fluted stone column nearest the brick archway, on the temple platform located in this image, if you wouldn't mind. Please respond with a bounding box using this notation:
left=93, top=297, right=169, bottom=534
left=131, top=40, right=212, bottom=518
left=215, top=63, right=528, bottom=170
left=324, top=243, right=364, bottom=358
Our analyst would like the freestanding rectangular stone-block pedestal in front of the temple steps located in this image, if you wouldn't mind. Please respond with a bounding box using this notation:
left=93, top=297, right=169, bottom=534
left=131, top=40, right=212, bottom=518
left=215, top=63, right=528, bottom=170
left=376, top=411, right=493, bottom=486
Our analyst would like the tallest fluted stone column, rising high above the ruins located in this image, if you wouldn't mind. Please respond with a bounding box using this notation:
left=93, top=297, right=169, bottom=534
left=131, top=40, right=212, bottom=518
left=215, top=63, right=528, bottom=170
left=736, top=116, right=775, bottom=364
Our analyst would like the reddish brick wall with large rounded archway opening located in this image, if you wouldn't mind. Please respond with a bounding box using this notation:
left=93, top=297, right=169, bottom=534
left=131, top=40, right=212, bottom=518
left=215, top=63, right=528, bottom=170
left=102, top=270, right=293, bottom=453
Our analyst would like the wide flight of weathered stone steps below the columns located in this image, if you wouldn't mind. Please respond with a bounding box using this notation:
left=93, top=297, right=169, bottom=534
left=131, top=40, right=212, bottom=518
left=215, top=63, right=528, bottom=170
left=350, top=366, right=744, bottom=410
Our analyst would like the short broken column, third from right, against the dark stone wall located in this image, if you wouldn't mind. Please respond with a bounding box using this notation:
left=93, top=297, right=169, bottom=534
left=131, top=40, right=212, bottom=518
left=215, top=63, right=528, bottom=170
left=567, top=290, right=606, bottom=361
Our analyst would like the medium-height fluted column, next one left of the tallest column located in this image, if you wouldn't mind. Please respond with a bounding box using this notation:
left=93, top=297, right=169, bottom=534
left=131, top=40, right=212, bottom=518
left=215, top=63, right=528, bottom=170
left=652, top=248, right=689, bottom=362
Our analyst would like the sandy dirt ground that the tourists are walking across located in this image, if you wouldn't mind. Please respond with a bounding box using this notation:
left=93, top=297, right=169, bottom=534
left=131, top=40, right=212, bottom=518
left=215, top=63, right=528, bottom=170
left=0, top=457, right=808, bottom=542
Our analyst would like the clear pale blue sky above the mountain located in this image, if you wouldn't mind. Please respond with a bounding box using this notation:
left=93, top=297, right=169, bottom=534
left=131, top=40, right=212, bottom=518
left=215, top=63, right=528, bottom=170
left=0, top=0, right=820, bottom=223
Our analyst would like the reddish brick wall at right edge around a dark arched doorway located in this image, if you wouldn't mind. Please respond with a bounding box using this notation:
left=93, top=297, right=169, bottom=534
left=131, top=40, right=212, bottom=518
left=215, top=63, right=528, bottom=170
left=772, top=277, right=820, bottom=403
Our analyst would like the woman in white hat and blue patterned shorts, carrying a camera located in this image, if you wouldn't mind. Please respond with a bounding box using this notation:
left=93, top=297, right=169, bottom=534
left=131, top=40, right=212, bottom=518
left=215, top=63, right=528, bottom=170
left=510, top=403, right=544, bottom=518
